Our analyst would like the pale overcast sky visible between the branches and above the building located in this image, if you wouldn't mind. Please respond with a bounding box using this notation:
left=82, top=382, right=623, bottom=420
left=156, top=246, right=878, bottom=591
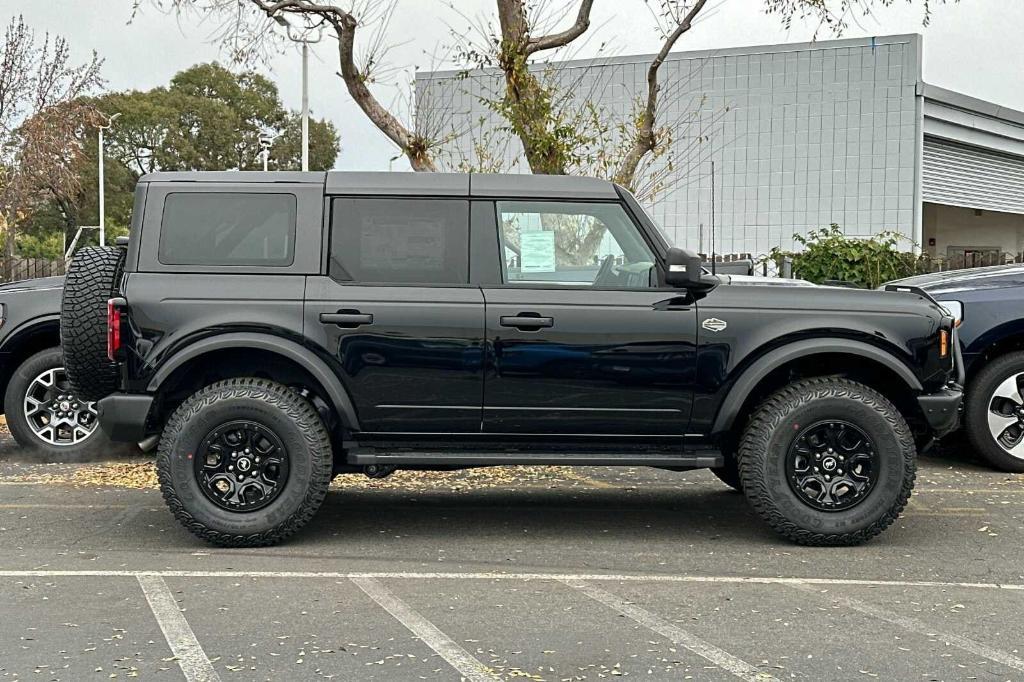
left=8, top=0, right=1024, bottom=170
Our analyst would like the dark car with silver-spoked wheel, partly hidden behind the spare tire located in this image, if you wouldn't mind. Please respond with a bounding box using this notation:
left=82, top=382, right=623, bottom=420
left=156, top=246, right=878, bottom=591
left=0, top=276, right=109, bottom=461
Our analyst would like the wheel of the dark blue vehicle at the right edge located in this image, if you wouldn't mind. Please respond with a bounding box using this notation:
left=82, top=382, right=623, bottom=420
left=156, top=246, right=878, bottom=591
left=964, top=352, right=1024, bottom=473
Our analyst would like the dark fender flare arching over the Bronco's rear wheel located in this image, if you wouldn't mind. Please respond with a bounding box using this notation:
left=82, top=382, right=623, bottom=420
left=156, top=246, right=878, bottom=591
left=146, top=332, right=359, bottom=430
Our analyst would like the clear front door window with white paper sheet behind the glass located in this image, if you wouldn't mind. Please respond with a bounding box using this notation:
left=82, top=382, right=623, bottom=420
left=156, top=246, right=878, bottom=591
left=497, top=202, right=654, bottom=289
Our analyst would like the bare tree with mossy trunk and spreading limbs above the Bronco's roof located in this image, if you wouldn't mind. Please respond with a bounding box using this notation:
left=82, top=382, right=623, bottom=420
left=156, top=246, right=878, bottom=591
left=148, top=0, right=956, bottom=188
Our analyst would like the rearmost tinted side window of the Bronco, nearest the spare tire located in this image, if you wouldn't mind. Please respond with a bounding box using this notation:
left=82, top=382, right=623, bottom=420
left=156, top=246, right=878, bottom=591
left=158, top=191, right=296, bottom=267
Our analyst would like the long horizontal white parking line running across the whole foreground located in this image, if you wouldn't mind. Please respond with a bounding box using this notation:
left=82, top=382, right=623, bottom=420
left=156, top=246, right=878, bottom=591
left=0, top=569, right=1024, bottom=591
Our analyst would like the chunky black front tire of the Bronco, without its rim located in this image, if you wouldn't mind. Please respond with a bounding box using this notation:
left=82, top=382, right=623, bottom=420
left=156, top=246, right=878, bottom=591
left=739, top=378, right=916, bottom=546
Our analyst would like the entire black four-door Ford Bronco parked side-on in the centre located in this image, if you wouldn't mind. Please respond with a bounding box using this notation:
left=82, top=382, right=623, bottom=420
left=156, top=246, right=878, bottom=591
left=60, top=172, right=963, bottom=546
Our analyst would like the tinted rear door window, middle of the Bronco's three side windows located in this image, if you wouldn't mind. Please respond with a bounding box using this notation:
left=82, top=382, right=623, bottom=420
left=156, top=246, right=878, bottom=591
left=329, top=199, right=469, bottom=285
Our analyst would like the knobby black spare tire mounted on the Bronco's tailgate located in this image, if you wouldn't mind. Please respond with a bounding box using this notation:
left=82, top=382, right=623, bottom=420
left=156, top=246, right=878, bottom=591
left=60, top=247, right=125, bottom=401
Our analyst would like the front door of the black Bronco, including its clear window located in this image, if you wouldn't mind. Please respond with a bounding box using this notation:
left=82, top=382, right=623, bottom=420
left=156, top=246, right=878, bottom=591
left=483, top=201, right=696, bottom=436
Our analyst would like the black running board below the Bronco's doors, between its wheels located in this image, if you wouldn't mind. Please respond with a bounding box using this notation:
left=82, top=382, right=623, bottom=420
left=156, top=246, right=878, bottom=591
left=346, top=450, right=725, bottom=469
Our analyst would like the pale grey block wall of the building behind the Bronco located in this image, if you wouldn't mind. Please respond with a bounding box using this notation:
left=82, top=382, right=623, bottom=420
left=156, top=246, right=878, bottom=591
left=417, top=36, right=922, bottom=254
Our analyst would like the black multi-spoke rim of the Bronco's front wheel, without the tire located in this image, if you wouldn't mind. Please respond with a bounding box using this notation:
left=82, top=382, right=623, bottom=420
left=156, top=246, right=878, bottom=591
left=785, top=420, right=879, bottom=511
